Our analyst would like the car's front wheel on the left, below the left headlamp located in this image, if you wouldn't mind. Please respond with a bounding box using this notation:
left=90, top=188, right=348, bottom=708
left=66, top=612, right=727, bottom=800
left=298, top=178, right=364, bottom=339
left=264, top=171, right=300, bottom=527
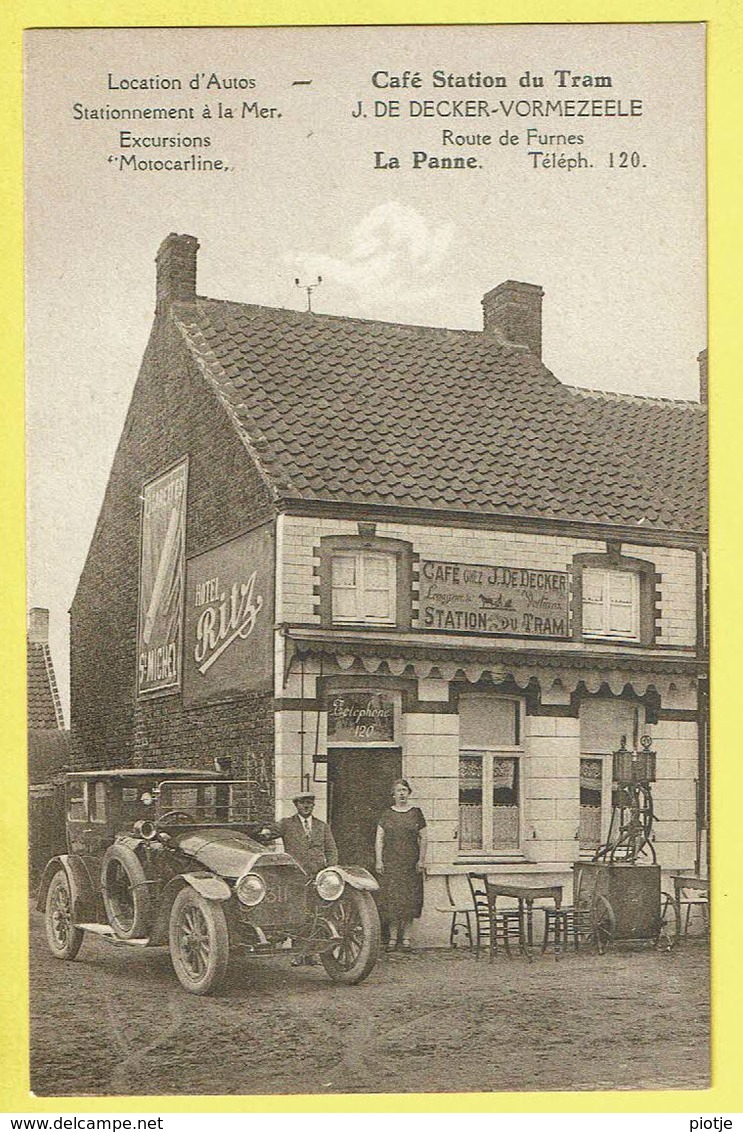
left=169, top=885, right=230, bottom=994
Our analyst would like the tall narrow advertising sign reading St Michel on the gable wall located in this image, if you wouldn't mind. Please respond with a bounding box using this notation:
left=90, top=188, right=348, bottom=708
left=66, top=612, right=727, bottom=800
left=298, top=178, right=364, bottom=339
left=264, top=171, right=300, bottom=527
left=137, top=460, right=188, bottom=696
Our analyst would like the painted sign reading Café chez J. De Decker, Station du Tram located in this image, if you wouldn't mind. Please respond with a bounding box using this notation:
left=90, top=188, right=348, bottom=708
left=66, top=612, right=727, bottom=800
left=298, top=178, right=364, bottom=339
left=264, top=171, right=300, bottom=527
left=418, top=559, right=570, bottom=637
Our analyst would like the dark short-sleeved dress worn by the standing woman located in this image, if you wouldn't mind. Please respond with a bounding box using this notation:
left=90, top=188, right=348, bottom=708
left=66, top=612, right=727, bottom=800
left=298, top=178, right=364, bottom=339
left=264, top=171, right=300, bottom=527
left=379, top=806, right=426, bottom=923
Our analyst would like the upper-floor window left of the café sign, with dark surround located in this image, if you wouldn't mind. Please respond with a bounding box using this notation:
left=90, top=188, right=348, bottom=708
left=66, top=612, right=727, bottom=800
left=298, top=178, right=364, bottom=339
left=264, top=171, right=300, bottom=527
left=318, top=533, right=413, bottom=628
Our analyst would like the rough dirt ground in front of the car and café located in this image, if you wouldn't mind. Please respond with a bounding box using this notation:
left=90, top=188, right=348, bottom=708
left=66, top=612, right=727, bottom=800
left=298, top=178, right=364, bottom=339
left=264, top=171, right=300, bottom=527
left=31, top=914, right=709, bottom=1096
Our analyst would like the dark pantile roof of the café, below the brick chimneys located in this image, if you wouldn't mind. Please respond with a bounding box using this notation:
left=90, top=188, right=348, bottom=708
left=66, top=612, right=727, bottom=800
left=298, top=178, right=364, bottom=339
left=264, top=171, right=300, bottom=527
left=172, top=299, right=707, bottom=531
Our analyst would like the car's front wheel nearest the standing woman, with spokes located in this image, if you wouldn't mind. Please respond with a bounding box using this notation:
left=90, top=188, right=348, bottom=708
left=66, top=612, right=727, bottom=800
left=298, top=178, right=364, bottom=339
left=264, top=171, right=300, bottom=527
left=319, top=887, right=382, bottom=986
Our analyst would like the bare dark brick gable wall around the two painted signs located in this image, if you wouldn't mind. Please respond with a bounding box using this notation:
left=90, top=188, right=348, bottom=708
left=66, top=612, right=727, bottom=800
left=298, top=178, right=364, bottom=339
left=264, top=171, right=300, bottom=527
left=70, top=319, right=273, bottom=815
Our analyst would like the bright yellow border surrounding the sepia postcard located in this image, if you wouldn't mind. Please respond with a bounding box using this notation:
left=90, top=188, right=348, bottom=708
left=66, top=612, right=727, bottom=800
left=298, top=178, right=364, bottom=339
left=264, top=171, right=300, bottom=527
left=0, top=0, right=743, bottom=1113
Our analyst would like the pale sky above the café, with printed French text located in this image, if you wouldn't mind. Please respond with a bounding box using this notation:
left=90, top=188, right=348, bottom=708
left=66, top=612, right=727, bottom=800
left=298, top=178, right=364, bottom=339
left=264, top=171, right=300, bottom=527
left=25, top=24, right=706, bottom=721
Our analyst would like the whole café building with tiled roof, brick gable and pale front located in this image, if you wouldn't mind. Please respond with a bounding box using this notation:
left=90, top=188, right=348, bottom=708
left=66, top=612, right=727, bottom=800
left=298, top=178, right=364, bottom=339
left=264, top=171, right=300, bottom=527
left=71, top=235, right=707, bottom=941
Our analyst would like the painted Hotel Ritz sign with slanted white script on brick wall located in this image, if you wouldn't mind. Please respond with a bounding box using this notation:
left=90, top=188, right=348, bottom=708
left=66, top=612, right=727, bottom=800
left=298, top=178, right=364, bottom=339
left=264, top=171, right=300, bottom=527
left=183, top=524, right=274, bottom=704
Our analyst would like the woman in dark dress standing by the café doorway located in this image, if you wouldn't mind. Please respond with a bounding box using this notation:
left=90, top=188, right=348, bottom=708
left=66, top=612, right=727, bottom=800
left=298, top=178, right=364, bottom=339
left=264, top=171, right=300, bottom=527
left=376, top=779, right=428, bottom=951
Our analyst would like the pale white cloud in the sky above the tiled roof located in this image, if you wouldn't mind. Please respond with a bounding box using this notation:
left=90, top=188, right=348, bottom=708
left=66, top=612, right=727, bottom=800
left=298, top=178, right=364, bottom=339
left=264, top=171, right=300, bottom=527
left=291, top=200, right=454, bottom=315
